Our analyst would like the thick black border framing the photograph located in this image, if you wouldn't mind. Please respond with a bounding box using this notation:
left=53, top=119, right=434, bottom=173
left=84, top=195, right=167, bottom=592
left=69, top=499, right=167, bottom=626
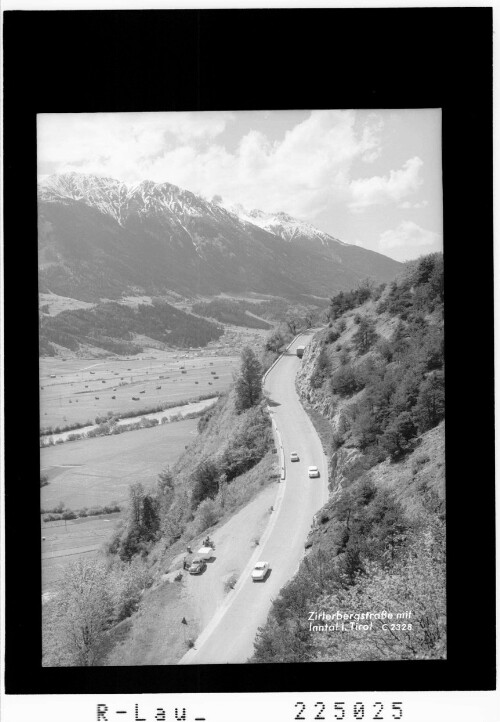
left=4, top=8, right=495, bottom=694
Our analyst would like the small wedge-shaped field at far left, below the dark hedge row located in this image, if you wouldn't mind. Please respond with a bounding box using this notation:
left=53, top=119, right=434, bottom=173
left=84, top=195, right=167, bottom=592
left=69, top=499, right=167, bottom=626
left=42, top=513, right=123, bottom=592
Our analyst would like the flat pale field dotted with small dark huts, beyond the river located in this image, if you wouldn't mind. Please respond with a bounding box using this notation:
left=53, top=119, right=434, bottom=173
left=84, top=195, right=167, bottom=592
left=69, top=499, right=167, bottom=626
left=40, top=351, right=239, bottom=430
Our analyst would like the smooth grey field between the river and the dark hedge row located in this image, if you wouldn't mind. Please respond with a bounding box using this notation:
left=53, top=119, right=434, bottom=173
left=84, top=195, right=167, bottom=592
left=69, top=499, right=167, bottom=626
left=40, top=419, right=198, bottom=509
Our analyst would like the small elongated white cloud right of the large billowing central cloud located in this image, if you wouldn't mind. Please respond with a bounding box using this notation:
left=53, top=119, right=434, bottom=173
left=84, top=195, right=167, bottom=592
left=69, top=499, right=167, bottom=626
left=349, top=156, right=423, bottom=212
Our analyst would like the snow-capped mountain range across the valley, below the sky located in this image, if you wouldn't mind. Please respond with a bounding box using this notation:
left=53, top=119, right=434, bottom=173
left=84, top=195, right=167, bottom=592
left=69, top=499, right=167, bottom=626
left=38, top=173, right=402, bottom=303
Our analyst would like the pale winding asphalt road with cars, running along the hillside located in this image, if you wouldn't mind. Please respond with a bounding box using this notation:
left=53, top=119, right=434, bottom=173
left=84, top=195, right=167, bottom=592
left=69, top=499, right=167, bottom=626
left=180, top=334, right=328, bottom=664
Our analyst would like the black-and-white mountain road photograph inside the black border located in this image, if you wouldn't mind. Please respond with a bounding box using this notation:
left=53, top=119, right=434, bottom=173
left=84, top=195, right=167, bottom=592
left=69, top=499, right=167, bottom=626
left=37, top=109, right=446, bottom=666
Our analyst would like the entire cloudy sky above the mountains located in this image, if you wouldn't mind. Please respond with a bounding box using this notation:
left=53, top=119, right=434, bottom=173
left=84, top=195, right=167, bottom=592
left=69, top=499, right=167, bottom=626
left=38, top=109, right=442, bottom=261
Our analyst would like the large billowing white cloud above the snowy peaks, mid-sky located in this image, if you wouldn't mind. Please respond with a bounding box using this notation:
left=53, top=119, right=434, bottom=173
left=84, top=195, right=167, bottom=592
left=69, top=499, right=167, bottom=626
left=139, top=111, right=378, bottom=216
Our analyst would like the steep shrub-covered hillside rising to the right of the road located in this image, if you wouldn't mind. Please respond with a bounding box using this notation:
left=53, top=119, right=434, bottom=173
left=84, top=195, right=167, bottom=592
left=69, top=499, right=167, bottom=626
left=252, top=254, right=446, bottom=662
